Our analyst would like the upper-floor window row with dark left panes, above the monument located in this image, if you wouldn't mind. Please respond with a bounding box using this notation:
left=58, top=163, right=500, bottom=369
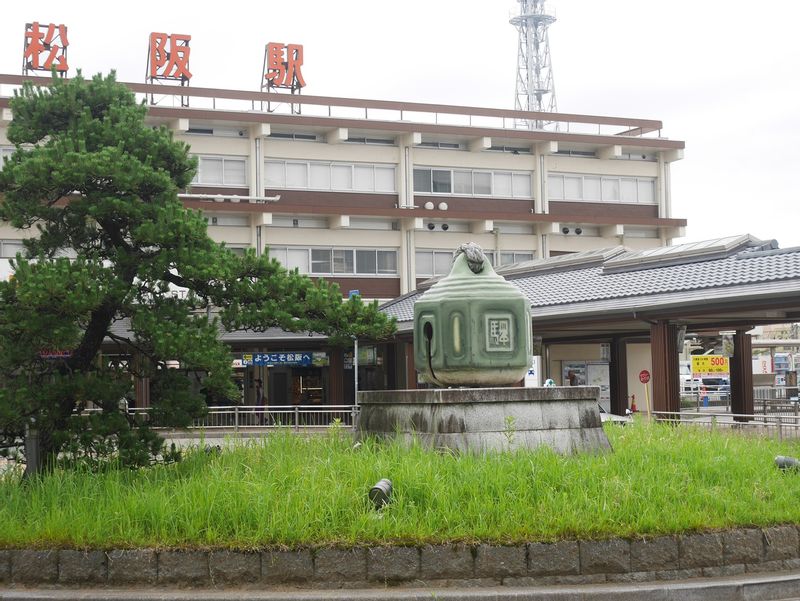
left=414, top=167, right=532, bottom=198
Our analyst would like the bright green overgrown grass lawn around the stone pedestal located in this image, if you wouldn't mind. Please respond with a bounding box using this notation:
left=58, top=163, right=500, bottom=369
left=0, top=422, right=800, bottom=549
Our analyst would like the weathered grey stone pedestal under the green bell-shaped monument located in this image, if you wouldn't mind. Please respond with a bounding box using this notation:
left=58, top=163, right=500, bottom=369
left=356, top=386, right=611, bottom=454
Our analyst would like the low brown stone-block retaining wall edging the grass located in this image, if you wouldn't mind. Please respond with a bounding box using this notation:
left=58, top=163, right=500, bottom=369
left=0, top=525, right=800, bottom=588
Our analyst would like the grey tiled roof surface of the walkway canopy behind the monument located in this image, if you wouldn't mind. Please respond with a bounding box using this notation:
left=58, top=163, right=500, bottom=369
left=382, top=236, right=800, bottom=322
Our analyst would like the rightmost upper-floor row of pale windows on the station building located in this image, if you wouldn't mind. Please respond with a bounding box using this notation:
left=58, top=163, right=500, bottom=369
left=547, top=174, right=656, bottom=204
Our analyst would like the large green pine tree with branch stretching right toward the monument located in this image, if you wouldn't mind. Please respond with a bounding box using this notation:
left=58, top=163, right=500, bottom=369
left=0, top=73, right=394, bottom=468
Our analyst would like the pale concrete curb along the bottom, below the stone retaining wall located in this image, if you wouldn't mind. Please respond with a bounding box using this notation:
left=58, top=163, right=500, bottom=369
left=0, top=572, right=800, bottom=601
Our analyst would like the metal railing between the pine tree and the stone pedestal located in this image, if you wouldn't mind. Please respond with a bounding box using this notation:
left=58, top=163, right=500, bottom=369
left=128, top=405, right=358, bottom=432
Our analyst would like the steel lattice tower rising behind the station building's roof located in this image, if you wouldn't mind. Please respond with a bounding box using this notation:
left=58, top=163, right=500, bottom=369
left=509, top=0, right=556, bottom=129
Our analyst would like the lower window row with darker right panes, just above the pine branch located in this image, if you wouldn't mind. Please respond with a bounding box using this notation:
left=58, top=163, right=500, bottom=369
left=269, top=247, right=397, bottom=275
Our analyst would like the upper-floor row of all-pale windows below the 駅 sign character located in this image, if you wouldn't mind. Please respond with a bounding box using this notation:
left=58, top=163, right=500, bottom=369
left=264, top=160, right=396, bottom=192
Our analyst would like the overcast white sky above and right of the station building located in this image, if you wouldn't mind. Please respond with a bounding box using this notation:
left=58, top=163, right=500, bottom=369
left=0, top=0, right=800, bottom=248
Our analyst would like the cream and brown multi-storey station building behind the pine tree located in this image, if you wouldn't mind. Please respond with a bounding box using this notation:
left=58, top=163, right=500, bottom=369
left=0, top=75, right=686, bottom=405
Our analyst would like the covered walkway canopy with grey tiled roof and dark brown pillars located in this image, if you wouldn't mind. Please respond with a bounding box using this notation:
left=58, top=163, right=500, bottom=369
left=383, top=235, right=800, bottom=413
